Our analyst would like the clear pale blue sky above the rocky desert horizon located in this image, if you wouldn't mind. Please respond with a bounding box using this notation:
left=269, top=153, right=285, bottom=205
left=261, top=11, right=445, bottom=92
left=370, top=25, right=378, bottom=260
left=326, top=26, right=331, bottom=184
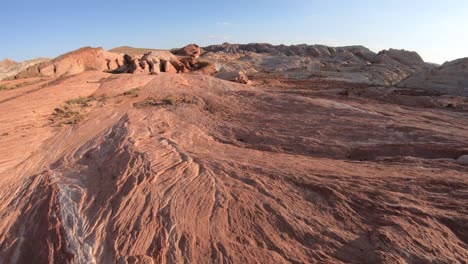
left=0, top=0, right=468, bottom=63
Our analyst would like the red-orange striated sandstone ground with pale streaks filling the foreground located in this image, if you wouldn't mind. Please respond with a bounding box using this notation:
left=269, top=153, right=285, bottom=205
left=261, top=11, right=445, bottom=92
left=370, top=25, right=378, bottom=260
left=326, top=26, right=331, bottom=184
left=0, top=72, right=468, bottom=263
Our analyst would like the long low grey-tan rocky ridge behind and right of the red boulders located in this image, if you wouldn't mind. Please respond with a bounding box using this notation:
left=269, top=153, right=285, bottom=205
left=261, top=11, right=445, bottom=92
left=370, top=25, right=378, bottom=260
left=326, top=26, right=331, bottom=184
left=202, top=43, right=430, bottom=86
